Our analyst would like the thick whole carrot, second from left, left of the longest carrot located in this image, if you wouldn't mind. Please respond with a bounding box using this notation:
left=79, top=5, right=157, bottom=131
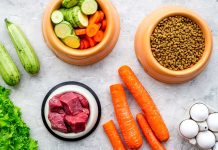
left=110, top=84, right=142, bottom=149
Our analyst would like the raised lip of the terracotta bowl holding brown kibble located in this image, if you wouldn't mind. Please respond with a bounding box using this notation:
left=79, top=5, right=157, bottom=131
left=141, top=6, right=212, bottom=76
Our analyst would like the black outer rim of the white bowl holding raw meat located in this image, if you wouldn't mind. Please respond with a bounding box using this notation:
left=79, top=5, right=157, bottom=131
left=41, top=81, right=101, bottom=141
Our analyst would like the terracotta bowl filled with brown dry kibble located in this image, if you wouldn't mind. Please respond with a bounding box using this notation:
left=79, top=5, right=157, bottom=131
left=135, top=6, right=212, bottom=83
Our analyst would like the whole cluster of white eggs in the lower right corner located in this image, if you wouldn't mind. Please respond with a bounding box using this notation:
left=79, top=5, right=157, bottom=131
left=179, top=103, right=218, bottom=150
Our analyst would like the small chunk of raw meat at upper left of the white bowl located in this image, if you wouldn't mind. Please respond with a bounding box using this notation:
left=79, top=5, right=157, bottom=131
left=49, top=96, right=64, bottom=114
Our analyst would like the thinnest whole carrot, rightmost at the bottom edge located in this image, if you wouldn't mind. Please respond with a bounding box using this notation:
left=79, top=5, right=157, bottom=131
left=136, top=113, right=165, bottom=150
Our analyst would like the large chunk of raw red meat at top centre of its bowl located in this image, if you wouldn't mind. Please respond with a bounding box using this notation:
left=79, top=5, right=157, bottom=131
left=60, top=92, right=82, bottom=115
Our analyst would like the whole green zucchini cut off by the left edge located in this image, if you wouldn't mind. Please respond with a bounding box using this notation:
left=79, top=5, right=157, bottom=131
left=0, top=42, right=20, bottom=86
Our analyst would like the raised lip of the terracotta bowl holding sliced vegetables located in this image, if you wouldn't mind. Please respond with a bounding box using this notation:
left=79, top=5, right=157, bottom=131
left=43, top=0, right=113, bottom=57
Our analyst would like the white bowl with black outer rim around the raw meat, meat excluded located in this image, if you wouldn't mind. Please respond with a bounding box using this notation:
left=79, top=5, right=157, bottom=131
left=41, top=81, right=101, bottom=141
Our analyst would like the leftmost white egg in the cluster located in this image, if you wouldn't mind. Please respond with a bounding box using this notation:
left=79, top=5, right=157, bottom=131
left=179, top=119, right=199, bottom=139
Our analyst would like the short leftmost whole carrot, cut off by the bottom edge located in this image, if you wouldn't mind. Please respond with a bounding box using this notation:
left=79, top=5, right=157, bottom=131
left=103, top=120, right=125, bottom=150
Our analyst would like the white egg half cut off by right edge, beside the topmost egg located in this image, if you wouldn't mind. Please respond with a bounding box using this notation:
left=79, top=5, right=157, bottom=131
left=207, top=113, right=218, bottom=132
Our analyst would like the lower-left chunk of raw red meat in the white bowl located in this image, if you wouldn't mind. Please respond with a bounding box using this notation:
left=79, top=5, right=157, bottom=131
left=48, top=112, right=67, bottom=133
